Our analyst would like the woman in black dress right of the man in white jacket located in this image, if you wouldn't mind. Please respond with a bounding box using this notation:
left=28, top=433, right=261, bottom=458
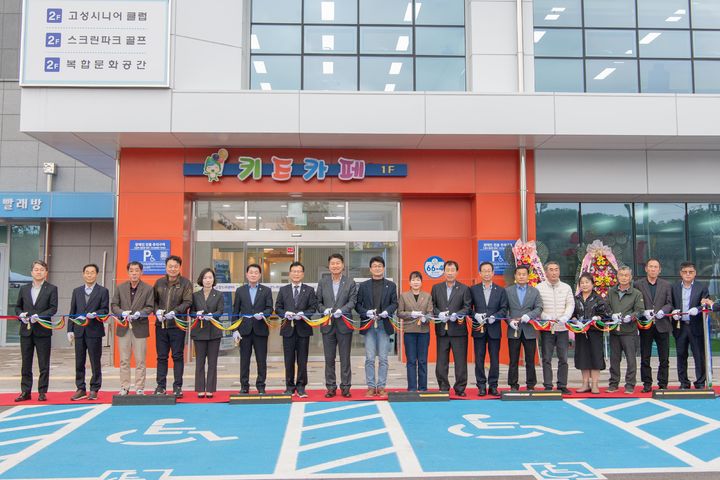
left=573, top=273, right=610, bottom=394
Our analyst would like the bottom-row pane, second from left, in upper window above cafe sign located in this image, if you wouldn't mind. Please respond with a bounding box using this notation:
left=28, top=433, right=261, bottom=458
left=303, top=57, right=357, bottom=90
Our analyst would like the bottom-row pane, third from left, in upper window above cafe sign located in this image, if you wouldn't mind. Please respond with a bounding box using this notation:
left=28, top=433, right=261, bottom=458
left=360, top=57, right=413, bottom=92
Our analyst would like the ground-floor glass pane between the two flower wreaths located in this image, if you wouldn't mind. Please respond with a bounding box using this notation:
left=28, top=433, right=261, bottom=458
left=535, top=203, right=580, bottom=287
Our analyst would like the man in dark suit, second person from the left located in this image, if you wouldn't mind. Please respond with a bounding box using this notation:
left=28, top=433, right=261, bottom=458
left=68, top=263, right=110, bottom=400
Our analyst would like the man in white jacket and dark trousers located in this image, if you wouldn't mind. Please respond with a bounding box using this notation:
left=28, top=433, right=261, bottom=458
left=535, top=261, right=575, bottom=395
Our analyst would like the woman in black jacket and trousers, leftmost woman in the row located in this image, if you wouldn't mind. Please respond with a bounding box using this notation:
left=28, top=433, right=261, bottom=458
left=191, top=268, right=225, bottom=398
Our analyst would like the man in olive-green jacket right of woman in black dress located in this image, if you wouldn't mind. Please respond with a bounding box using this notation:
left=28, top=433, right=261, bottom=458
left=606, top=266, right=645, bottom=395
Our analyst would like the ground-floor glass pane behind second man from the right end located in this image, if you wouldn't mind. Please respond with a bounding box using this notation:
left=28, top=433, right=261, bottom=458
left=635, top=203, right=686, bottom=275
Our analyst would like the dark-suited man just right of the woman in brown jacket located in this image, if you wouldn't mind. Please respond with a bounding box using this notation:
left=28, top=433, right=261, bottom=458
left=430, top=260, right=472, bottom=397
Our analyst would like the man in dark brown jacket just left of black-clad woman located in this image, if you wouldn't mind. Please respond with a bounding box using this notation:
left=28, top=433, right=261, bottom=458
left=153, top=255, right=192, bottom=398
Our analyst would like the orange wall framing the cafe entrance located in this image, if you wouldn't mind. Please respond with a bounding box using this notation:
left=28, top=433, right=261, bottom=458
left=115, top=149, right=535, bottom=366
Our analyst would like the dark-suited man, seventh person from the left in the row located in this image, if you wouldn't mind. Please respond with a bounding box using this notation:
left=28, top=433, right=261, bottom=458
left=275, top=262, right=317, bottom=398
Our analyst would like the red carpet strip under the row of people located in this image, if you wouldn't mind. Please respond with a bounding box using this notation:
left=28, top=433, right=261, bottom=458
left=0, top=387, right=720, bottom=406
